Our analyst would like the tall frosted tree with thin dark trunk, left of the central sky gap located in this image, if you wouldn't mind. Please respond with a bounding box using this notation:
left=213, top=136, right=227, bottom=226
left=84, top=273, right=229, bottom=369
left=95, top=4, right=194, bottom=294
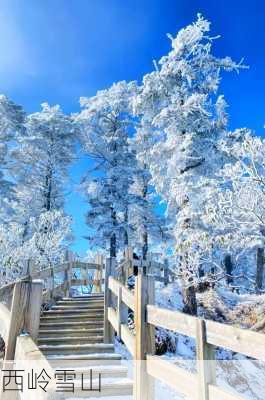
left=12, top=103, right=77, bottom=234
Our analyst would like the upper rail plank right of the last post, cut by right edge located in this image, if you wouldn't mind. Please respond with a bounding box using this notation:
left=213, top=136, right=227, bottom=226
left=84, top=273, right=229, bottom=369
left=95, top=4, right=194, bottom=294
left=205, top=320, right=265, bottom=361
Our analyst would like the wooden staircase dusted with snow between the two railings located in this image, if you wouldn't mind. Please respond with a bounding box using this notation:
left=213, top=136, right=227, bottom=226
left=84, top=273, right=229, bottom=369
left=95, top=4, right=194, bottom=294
left=37, top=294, right=133, bottom=398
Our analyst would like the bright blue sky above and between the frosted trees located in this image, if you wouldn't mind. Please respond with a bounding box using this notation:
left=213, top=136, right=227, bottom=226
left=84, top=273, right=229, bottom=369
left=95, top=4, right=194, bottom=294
left=0, top=0, right=265, bottom=254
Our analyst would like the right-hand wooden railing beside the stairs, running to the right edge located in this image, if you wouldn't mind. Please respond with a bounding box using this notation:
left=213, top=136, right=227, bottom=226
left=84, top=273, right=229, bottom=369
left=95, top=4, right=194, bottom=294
left=105, top=268, right=265, bottom=400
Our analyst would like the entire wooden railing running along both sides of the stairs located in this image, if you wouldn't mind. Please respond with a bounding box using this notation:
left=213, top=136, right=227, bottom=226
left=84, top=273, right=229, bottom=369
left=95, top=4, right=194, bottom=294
left=0, top=250, right=265, bottom=400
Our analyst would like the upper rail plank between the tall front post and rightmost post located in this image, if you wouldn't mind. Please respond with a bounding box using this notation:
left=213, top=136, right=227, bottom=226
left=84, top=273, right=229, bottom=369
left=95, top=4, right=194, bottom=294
left=147, top=305, right=197, bottom=338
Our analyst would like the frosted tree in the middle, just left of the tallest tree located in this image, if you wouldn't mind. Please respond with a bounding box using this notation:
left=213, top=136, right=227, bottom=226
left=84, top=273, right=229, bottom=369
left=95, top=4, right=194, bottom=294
left=77, top=82, right=136, bottom=257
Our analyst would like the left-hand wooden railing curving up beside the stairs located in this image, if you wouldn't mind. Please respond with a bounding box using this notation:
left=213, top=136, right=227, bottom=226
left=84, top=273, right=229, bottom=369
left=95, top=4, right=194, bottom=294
left=0, top=256, right=104, bottom=360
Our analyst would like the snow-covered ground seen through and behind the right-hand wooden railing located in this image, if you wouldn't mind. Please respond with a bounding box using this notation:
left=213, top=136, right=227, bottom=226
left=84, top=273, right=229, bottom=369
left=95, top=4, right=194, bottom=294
left=156, top=282, right=265, bottom=400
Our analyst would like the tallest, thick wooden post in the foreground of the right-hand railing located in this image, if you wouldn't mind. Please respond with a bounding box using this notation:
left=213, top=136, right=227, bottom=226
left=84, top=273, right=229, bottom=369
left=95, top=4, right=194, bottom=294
left=133, top=274, right=155, bottom=400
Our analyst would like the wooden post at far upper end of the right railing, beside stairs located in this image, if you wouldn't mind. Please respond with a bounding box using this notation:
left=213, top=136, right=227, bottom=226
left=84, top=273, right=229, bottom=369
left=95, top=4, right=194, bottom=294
left=104, top=258, right=116, bottom=343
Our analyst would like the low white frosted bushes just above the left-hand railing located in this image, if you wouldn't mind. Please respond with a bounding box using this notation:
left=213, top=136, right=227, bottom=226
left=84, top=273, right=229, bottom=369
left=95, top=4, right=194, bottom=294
left=0, top=211, right=71, bottom=286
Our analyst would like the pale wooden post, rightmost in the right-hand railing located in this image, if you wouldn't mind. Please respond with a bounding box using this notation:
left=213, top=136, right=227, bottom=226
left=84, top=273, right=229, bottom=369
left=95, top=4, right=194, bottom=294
left=196, top=319, right=216, bottom=400
